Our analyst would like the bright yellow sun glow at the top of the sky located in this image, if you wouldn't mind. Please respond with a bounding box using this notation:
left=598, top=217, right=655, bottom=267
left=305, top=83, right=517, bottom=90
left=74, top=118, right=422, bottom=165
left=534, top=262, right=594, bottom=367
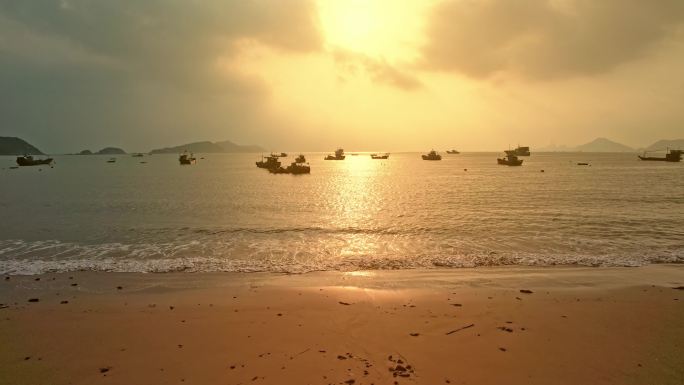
left=318, top=0, right=431, bottom=58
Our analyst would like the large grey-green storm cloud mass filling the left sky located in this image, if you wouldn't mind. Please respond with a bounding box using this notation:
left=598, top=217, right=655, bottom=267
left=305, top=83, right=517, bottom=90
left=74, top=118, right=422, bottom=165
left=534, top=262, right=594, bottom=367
left=0, top=0, right=321, bottom=150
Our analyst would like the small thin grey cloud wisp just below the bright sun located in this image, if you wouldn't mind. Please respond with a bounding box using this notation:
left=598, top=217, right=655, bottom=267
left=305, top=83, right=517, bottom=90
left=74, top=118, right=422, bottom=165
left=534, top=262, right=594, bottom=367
left=333, top=48, right=423, bottom=91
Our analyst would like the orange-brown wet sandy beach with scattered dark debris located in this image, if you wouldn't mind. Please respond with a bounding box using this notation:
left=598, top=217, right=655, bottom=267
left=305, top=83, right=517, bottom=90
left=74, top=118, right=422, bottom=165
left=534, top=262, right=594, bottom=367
left=0, top=265, right=684, bottom=385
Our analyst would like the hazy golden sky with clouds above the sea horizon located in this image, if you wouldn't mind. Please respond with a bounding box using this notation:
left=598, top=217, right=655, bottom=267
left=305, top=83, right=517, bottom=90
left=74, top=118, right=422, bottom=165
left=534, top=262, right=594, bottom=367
left=0, top=0, right=684, bottom=153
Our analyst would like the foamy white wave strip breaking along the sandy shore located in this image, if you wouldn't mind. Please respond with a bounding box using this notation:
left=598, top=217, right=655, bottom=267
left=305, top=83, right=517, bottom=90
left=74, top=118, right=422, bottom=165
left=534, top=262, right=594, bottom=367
left=0, top=240, right=684, bottom=275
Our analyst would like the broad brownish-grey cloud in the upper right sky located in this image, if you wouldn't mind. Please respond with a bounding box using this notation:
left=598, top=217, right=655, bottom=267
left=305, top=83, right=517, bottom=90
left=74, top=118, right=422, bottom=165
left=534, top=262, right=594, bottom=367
left=422, top=0, right=684, bottom=80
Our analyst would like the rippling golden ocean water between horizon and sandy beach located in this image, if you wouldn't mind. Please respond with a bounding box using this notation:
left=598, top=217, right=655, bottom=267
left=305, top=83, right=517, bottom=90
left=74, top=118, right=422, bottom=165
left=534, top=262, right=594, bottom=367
left=0, top=153, right=684, bottom=274
